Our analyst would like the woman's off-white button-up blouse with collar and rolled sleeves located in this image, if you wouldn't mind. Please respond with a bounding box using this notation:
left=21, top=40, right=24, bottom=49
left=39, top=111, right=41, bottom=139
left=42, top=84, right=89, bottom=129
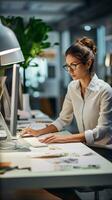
left=52, top=74, right=112, bottom=144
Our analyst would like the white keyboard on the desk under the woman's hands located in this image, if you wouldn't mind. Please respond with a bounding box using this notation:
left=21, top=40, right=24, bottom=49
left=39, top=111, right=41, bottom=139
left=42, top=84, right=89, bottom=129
left=18, top=137, right=48, bottom=148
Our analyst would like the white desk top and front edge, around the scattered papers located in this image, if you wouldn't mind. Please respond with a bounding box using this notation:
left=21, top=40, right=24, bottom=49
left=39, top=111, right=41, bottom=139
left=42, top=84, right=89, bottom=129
left=0, top=143, right=112, bottom=189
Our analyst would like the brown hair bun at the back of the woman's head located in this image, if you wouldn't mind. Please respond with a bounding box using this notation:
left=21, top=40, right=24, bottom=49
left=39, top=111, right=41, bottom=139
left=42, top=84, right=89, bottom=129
left=77, top=37, right=96, bottom=55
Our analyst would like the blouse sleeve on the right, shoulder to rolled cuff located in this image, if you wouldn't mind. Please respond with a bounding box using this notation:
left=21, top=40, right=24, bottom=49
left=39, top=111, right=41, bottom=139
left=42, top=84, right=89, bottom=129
left=85, top=87, right=112, bottom=144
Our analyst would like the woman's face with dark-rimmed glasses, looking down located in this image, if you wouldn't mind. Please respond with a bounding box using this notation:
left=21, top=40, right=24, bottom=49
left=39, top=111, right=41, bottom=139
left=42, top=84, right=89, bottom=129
left=66, top=55, right=89, bottom=80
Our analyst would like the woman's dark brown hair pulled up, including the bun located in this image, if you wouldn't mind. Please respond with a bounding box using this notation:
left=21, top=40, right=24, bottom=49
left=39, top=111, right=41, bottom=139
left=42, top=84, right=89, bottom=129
left=65, top=37, right=96, bottom=73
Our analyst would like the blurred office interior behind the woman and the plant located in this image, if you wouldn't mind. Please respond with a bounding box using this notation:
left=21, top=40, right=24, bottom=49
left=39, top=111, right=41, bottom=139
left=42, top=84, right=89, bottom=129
left=0, top=0, right=112, bottom=118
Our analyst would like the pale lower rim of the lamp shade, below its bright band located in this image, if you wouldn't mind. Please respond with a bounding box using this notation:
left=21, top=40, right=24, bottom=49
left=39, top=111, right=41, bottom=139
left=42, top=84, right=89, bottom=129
left=0, top=49, right=24, bottom=66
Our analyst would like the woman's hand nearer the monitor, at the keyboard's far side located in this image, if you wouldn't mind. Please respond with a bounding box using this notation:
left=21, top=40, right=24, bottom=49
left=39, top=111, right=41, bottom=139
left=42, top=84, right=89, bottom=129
left=20, top=128, right=40, bottom=137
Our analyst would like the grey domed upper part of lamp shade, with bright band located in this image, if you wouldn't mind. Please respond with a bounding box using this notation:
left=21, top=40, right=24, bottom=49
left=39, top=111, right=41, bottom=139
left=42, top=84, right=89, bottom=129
left=0, top=22, right=20, bottom=56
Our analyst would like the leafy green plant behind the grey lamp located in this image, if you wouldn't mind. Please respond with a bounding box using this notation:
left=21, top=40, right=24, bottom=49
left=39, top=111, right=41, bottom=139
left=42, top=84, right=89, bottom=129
left=1, top=16, right=57, bottom=93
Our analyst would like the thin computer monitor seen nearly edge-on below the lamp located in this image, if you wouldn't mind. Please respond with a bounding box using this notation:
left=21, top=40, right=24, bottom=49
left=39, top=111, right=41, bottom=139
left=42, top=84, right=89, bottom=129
left=1, top=64, right=19, bottom=136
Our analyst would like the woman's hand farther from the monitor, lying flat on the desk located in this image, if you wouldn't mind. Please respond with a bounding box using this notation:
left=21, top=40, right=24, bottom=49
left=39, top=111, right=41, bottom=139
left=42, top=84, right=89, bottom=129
left=39, top=134, right=70, bottom=144
